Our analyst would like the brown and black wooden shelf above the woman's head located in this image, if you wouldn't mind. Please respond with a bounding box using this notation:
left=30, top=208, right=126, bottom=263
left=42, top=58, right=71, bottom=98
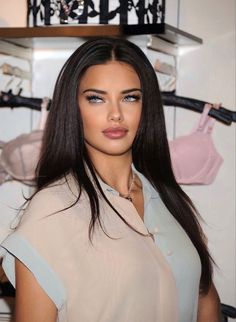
left=0, top=23, right=202, bottom=51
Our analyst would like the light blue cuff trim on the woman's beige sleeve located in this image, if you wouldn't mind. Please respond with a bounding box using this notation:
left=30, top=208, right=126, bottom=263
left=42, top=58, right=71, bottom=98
left=1, top=232, right=66, bottom=310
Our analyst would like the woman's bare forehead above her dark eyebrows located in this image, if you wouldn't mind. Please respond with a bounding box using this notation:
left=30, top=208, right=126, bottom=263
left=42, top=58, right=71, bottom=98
left=80, top=61, right=140, bottom=88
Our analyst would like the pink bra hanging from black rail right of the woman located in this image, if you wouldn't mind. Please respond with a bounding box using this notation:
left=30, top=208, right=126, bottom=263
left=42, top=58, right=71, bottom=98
left=169, top=104, right=223, bottom=184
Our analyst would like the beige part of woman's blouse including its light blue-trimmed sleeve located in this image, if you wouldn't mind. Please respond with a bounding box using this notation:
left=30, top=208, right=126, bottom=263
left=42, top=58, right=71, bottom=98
left=2, top=177, right=179, bottom=322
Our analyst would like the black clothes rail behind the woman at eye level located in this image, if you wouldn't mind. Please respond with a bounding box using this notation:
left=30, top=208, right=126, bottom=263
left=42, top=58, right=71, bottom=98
left=0, top=90, right=236, bottom=125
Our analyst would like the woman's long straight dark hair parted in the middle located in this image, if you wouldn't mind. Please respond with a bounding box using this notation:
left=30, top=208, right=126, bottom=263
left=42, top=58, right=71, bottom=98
left=37, top=38, right=212, bottom=292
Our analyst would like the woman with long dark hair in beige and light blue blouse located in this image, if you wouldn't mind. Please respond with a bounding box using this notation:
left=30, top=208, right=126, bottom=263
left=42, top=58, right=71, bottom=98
left=2, top=38, right=219, bottom=322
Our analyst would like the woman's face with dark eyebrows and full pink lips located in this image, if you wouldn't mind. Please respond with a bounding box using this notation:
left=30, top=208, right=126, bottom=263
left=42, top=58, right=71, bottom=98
left=78, top=61, right=142, bottom=155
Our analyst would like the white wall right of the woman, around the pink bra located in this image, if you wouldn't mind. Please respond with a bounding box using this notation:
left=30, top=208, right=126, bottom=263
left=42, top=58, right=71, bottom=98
left=175, top=0, right=236, bottom=306
